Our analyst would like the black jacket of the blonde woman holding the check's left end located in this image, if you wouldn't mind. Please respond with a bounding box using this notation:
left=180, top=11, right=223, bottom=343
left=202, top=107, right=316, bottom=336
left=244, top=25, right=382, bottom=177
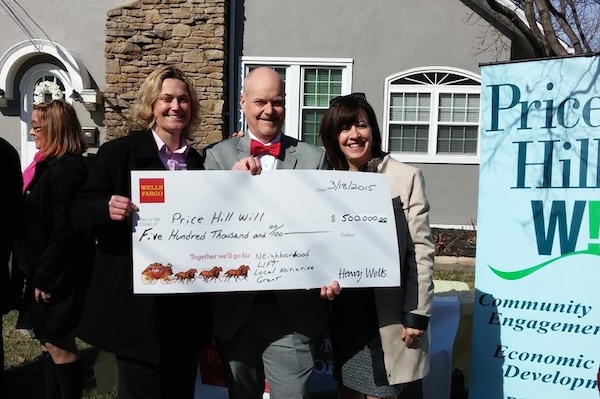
left=73, top=130, right=210, bottom=364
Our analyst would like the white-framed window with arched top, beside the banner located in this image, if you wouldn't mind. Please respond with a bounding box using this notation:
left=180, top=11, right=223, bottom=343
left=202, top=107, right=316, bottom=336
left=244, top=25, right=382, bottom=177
left=382, top=67, right=481, bottom=164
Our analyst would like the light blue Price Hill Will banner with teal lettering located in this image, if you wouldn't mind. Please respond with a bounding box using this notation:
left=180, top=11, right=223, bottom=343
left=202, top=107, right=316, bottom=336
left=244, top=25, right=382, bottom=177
left=469, top=56, right=600, bottom=399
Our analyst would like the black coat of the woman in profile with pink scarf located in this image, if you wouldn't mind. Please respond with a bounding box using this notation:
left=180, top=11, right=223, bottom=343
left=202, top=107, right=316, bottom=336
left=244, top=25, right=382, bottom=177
left=13, top=154, right=93, bottom=339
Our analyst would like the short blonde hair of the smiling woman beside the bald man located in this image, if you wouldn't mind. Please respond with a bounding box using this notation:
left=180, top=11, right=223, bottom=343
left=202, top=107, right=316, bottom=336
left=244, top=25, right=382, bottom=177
left=129, top=65, right=200, bottom=139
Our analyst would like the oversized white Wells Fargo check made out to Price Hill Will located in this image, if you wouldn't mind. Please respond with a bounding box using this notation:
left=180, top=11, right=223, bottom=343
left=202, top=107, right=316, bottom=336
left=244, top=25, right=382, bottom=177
left=131, top=170, right=400, bottom=294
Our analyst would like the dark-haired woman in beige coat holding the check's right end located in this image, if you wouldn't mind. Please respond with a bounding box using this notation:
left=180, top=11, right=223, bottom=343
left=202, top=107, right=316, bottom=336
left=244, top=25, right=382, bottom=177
left=319, top=93, right=434, bottom=399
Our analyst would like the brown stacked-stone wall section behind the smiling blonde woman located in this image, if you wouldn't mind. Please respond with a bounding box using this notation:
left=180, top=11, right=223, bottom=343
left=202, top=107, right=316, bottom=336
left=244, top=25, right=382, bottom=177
left=104, top=0, right=227, bottom=148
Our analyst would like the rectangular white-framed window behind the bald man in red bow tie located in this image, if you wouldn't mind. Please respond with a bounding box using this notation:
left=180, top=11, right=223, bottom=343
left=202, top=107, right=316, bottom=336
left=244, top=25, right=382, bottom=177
left=240, top=57, right=352, bottom=145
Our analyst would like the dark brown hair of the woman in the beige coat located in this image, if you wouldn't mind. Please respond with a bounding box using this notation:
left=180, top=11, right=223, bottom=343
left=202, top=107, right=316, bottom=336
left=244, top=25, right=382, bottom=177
left=319, top=96, right=385, bottom=170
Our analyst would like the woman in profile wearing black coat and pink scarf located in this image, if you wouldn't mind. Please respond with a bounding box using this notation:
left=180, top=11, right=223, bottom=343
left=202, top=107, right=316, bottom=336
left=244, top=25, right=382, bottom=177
left=13, top=100, right=93, bottom=399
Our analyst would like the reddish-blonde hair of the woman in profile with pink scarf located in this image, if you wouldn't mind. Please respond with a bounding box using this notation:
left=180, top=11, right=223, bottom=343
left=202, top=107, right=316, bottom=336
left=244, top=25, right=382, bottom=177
left=33, top=100, right=88, bottom=158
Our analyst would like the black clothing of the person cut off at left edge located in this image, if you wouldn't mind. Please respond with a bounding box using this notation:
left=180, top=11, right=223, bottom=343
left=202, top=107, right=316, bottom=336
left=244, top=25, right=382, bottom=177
left=0, top=138, right=23, bottom=315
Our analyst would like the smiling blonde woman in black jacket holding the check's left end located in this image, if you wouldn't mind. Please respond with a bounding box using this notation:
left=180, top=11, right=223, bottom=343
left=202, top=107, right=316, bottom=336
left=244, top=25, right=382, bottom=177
left=73, top=66, right=210, bottom=399
